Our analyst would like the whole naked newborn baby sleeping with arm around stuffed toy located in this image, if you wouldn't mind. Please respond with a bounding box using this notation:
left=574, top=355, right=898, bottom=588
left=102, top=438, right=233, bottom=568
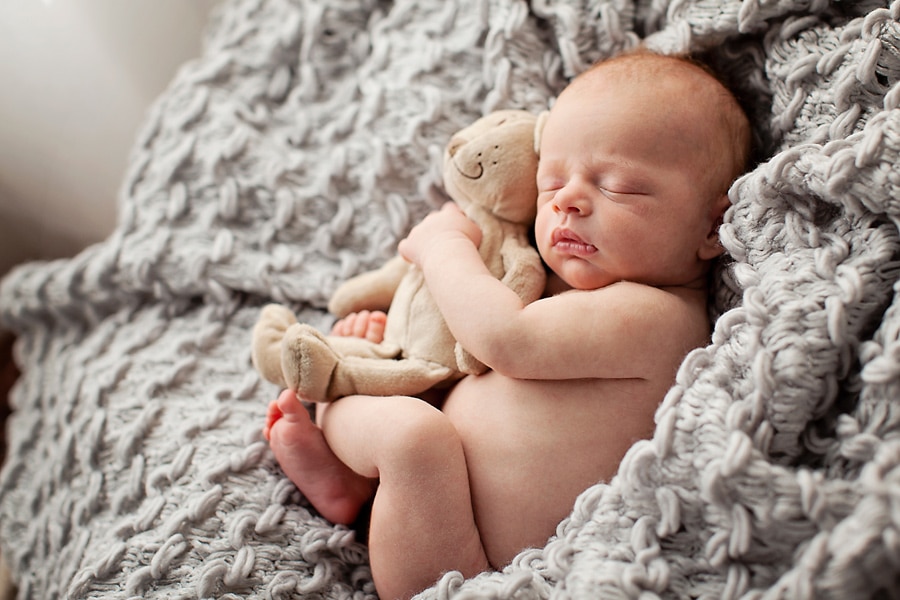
left=266, top=50, right=750, bottom=598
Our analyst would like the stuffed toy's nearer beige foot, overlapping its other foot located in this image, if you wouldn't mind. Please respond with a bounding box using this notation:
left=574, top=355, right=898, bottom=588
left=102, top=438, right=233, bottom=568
left=281, top=323, right=340, bottom=402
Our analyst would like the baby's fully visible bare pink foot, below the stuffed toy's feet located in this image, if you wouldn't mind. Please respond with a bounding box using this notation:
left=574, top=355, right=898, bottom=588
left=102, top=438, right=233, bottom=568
left=264, top=390, right=376, bottom=525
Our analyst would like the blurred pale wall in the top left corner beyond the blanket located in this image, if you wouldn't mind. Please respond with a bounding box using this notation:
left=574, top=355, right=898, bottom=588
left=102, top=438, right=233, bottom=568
left=0, top=0, right=216, bottom=274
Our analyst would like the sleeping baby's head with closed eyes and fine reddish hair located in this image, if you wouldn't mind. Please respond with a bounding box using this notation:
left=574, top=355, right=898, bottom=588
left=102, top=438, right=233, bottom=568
left=535, top=51, right=751, bottom=289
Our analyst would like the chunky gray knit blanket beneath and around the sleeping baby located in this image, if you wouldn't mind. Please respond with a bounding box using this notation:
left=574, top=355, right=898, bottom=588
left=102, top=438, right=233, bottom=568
left=0, top=0, right=900, bottom=600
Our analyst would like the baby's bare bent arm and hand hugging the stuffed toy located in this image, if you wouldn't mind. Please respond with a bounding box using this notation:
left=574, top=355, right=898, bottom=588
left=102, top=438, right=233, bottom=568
left=400, top=205, right=708, bottom=380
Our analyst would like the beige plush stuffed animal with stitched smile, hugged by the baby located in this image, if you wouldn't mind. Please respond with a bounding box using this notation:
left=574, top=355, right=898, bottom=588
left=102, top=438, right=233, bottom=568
left=252, top=110, right=545, bottom=402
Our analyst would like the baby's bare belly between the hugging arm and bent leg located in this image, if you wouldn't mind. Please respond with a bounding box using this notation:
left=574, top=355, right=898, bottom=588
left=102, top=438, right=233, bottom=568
left=443, top=372, right=665, bottom=568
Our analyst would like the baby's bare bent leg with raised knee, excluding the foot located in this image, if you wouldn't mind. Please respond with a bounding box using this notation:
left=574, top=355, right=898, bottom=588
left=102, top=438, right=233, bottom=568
left=321, top=396, right=489, bottom=598
